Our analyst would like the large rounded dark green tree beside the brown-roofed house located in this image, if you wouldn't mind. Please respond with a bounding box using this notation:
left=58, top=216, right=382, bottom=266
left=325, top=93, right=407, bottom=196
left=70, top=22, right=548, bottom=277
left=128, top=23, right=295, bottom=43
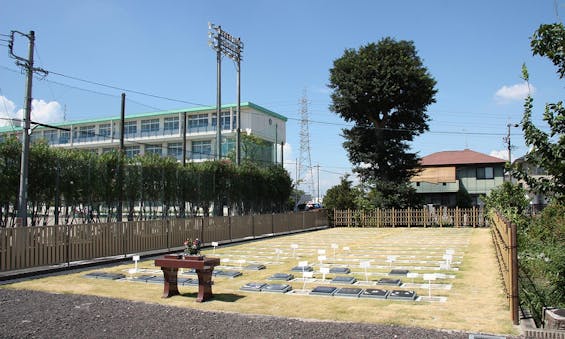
left=329, top=38, right=437, bottom=207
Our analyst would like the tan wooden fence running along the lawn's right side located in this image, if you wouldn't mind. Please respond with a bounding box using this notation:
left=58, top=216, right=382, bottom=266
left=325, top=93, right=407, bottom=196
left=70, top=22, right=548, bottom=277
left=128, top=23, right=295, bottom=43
left=491, top=212, right=520, bottom=325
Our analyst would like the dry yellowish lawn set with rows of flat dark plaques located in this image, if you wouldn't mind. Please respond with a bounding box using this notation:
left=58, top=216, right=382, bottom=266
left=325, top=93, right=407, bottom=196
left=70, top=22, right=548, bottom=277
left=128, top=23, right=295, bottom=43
left=3, top=228, right=518, bottom=335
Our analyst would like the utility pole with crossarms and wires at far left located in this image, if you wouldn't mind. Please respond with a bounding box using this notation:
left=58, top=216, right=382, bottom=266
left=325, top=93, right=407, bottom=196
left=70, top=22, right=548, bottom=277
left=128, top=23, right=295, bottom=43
left=8, top=31, right=47, bottom=226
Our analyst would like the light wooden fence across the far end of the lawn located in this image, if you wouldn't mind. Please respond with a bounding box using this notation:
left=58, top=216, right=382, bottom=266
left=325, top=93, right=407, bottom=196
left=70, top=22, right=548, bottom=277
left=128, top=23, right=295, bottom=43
left=333, top=207, right=487, bottom=227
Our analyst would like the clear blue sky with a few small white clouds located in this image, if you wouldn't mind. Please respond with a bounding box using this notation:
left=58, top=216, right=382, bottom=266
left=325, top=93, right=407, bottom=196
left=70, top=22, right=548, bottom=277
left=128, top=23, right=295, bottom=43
left=0, top=0, right=565, bottom=199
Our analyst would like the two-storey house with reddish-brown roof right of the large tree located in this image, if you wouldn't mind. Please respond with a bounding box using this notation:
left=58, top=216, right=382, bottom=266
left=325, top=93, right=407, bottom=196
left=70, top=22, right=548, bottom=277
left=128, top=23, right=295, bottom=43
left=410, top=149, right=506, bottom=207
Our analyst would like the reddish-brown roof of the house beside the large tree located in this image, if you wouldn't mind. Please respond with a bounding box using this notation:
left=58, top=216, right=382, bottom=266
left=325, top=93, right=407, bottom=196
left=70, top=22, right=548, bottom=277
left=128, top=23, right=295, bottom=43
left=420, top=149, right=506, bottom=166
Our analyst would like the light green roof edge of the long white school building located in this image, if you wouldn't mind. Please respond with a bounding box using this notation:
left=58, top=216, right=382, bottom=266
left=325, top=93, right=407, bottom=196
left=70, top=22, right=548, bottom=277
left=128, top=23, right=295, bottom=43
left=0, top=102, right=288, bottom=133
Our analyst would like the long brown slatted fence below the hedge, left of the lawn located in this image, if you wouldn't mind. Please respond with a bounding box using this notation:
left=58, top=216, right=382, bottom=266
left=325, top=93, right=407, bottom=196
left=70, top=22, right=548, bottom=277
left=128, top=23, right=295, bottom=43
left=0, top=210, right=328, bottom=272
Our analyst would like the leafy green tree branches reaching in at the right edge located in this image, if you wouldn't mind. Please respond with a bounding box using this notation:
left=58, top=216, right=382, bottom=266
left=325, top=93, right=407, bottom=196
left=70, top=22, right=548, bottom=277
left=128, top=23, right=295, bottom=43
left=513, top=23, right=565, bottom=204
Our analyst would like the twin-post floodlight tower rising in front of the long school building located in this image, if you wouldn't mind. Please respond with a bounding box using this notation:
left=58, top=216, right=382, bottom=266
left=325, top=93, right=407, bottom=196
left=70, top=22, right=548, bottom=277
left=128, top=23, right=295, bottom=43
left=208, top=23, right=243, bottom=165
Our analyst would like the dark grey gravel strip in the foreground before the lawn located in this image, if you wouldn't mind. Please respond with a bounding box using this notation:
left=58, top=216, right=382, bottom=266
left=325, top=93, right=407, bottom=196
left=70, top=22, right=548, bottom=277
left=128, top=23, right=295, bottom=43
left=0, top=288, right=520, bottom=338
